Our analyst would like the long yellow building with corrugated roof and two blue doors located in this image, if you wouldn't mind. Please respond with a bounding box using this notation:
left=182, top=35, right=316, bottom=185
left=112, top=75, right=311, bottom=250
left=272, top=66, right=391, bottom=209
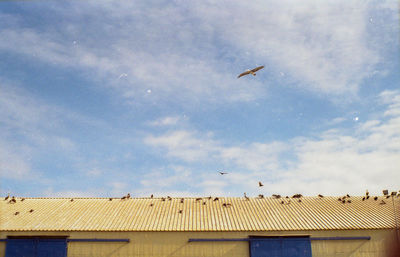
left=0, top=196, right=400, bottom=257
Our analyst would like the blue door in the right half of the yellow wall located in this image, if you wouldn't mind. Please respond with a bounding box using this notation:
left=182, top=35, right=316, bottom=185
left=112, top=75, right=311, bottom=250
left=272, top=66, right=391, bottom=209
left=250, top=237, right=311, bottom=257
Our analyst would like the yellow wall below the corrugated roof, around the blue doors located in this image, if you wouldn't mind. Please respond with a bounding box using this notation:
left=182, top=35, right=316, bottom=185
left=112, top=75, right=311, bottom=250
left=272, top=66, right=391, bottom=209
left=0, top=230, right=400, bottom=257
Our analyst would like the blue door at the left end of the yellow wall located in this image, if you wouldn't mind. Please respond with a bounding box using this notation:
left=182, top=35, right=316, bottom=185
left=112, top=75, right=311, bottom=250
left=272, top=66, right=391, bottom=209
left=5, top=238, right=67, bottom=257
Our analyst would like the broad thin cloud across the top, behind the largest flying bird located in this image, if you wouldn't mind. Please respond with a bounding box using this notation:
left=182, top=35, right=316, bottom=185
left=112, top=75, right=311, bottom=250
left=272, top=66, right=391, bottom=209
left=0, top=1, right=394, bottom=105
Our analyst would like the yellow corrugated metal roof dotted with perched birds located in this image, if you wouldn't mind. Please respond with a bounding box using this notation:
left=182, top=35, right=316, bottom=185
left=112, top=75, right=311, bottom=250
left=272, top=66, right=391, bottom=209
left=0, top=197, right=400, bottom=231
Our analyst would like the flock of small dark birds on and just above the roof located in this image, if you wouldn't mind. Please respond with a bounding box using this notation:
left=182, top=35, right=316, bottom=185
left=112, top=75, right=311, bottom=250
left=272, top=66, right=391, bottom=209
left=4, top=187, right=400, bottom=215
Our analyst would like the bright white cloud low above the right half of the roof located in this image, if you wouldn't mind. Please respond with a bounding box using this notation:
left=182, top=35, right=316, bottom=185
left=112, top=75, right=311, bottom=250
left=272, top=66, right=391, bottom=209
left=145, top=91, right=400, bottom=195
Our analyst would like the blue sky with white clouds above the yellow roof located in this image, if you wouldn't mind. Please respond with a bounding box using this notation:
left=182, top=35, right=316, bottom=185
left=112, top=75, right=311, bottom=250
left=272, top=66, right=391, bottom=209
left=0, top=0, right=400, bottom=197
